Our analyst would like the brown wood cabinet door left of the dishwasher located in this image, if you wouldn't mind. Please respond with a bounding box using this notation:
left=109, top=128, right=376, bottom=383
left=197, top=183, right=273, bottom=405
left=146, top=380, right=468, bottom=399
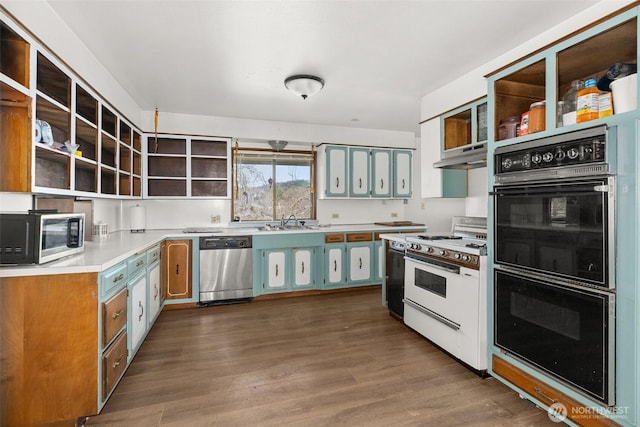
left=162, top=239, right=192, bottom=299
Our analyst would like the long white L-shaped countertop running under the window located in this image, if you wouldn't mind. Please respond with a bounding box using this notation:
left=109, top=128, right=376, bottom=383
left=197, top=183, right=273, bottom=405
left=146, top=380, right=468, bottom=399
left=0, top=224, right=426, bottom=278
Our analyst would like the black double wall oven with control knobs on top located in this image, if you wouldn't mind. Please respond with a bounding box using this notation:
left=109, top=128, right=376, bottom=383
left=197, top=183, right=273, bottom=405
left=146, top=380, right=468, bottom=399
left=492, top=127, right=615, bottom=405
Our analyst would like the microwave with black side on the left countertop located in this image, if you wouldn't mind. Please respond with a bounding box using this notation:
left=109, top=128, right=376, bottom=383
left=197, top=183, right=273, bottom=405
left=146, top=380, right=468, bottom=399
left=0, top=212, right=85, bottom=265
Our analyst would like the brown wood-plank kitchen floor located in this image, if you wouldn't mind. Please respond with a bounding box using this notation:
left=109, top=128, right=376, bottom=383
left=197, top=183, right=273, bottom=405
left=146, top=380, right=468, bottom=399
left=87, top=289, right=558, bottom=427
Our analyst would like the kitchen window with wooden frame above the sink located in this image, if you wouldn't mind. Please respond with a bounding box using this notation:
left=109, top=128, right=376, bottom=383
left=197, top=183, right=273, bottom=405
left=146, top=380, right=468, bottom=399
left=232, top=148, right=315, bottom=221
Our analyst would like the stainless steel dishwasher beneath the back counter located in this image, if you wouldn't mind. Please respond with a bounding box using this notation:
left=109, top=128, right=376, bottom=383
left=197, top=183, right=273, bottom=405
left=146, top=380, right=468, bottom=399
left=199, top=236, right=253, bottom=306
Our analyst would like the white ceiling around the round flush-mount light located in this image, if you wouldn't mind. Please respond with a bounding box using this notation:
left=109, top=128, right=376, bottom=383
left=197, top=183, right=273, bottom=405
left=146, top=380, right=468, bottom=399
left=49, top=0, right=597, bottom=134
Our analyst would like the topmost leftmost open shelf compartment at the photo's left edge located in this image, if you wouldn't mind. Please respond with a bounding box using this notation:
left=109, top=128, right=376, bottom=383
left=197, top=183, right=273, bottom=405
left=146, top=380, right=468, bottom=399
left=0, top=21, right=30, bottom=88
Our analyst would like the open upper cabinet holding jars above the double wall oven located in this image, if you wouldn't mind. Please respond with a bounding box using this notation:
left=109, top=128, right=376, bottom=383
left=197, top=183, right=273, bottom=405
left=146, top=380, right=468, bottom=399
left=487, top=7, right=638, bottom=143
